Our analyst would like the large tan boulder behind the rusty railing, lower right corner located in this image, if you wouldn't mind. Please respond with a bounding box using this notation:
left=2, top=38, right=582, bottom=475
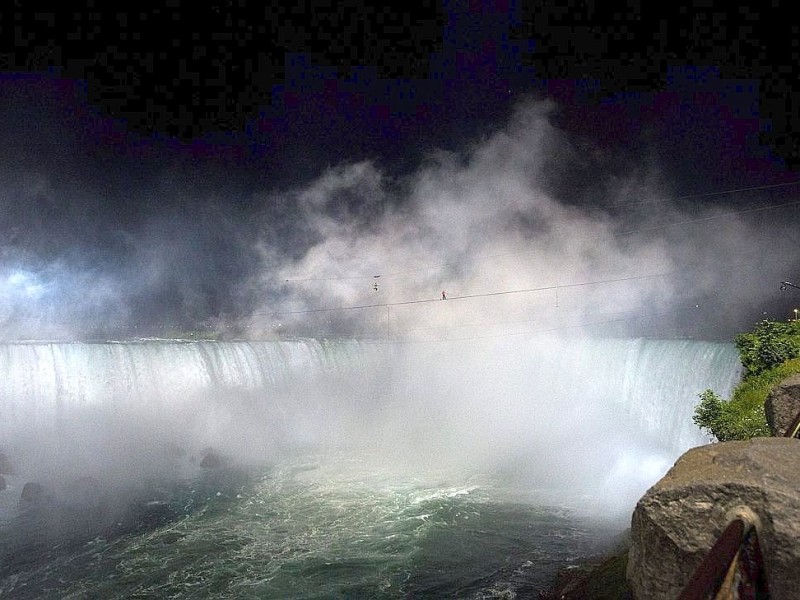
left=627, top=438, right=800, bottom=600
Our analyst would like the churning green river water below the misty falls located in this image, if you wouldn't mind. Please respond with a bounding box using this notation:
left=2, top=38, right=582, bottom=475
left=0, top=455, right=618, bottom=599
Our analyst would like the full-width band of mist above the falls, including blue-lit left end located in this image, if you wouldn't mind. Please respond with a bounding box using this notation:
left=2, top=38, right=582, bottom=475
left=0, top=98, right=800, bottom=339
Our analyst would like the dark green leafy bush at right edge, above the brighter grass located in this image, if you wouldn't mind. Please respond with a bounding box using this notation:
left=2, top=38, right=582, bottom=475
left=735, top=321, right=800, bottom=377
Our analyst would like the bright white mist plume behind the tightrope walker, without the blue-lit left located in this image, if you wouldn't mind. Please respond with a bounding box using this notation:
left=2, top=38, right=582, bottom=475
left=250, top=100, right=796, bottom=337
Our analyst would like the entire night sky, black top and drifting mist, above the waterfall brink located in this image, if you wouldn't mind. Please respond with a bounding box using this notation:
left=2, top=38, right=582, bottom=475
left=0, top=0, right=800, bottom=338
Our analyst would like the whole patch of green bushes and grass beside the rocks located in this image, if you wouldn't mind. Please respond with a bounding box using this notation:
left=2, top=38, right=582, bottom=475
left=692, top=321, right=800, bottom=442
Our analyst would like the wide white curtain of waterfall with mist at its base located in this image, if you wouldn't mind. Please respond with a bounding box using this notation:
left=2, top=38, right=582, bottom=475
left=0, top=336, right=740, bottom=506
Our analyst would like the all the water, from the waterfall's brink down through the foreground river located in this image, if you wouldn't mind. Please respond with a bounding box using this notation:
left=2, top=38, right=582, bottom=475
left=0, top=336, right=740, bottom=598
